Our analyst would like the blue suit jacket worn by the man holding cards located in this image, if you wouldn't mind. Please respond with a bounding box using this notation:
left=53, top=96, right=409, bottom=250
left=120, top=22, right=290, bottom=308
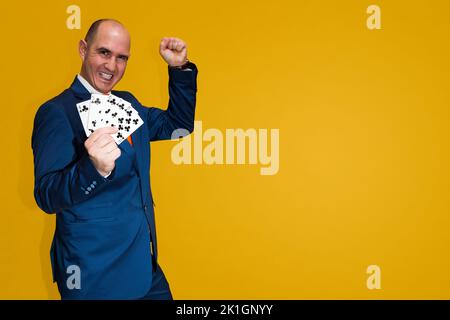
left=32, top=64, right=197, bottom=299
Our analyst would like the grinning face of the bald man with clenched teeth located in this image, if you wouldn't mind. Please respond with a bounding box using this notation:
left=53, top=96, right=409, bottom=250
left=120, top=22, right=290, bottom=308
left=79, top=21, right=130, bottom=93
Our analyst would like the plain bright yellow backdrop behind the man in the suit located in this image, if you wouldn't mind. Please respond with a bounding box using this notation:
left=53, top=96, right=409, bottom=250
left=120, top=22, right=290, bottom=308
left=0, top=0, right=450, bottom=299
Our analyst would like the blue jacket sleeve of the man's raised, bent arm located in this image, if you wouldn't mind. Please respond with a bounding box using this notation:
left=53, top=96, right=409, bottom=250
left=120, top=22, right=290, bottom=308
left=146, top=63, right=198, bottom=141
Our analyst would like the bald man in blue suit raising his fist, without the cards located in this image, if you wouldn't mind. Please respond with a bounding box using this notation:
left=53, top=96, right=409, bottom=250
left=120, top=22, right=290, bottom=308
left=32, top=19, right=198, bottom=299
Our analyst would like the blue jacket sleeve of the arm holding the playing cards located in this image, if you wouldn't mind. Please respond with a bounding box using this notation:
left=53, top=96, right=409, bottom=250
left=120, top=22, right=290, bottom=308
left=31, top=103, right=110, bottom=213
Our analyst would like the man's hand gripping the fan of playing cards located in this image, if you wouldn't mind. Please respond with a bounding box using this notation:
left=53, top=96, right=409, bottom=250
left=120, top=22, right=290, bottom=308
left=84, top=127, right=120, bottom=177
